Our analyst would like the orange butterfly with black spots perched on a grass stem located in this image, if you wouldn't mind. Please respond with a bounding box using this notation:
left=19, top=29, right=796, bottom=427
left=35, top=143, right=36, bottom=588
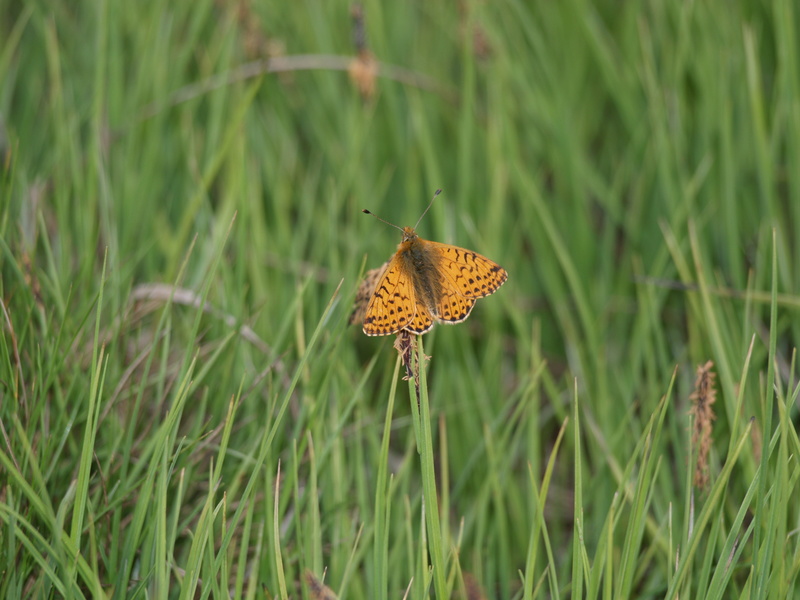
left=351, top=190, right=508, bottom=335
